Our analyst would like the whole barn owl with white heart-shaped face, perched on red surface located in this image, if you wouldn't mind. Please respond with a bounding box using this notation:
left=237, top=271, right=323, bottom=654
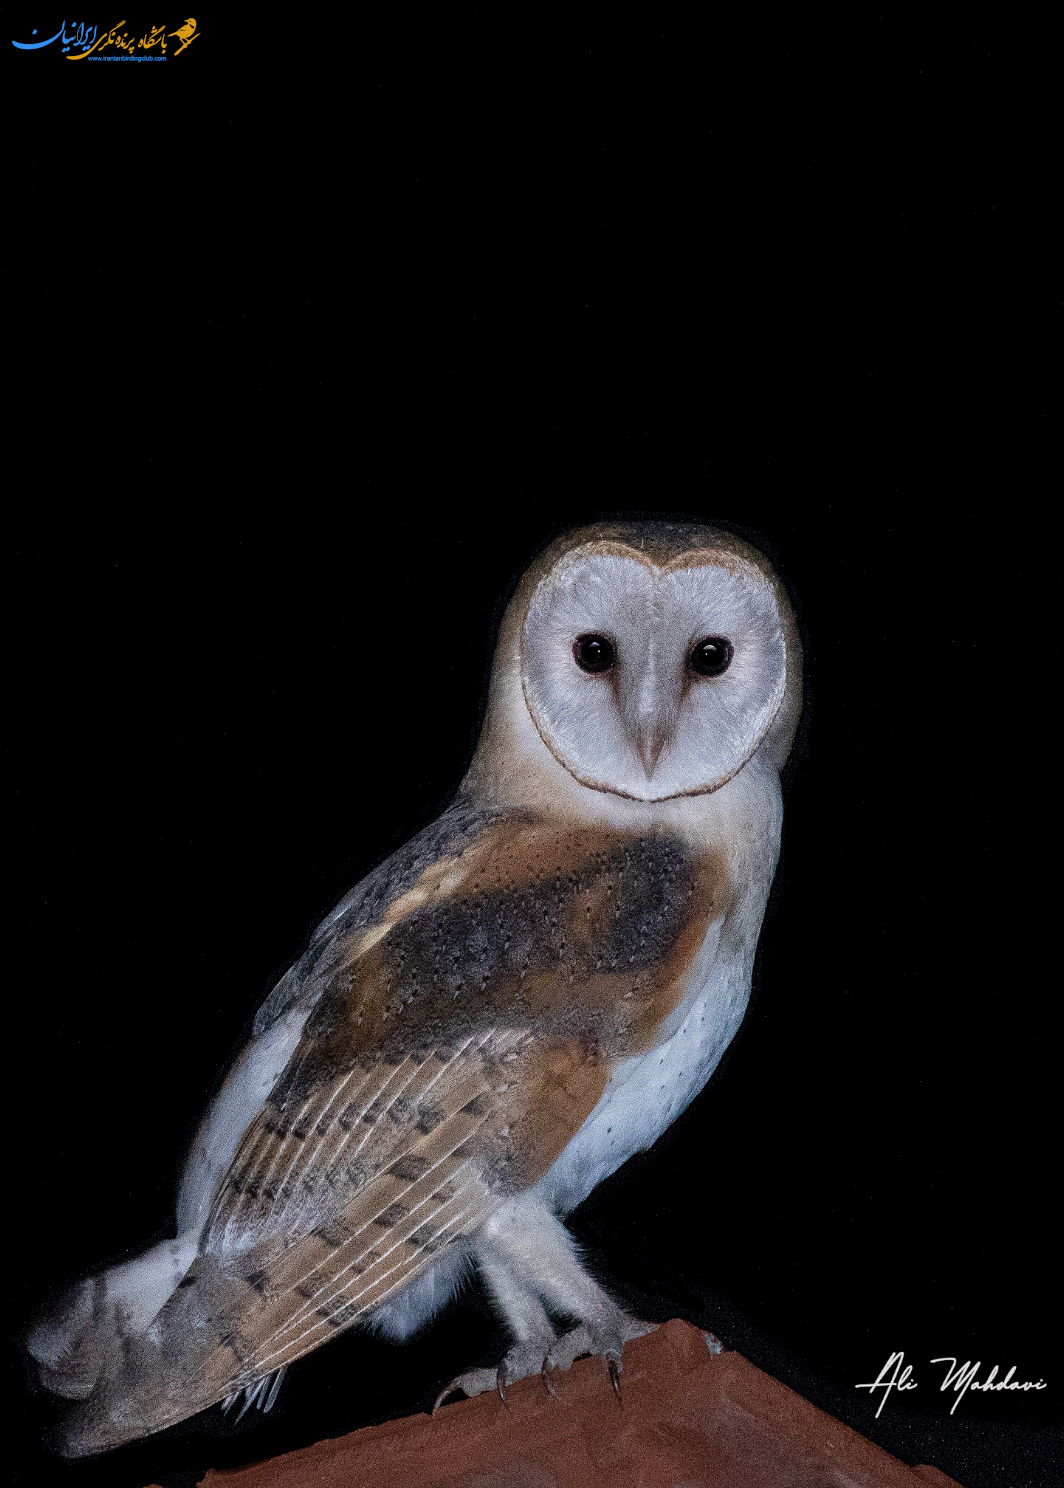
left=25, top=522, right=801, bottom=1457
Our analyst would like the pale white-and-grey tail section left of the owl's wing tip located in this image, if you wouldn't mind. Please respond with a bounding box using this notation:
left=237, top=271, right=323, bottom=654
left=24, top=1235, right=196, bottom=1400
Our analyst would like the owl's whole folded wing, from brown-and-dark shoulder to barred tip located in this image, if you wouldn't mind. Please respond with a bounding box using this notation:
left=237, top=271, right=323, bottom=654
left=62, top=812, right=726, bottom=1449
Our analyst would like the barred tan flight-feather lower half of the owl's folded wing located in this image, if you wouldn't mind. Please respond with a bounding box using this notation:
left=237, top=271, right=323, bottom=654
left=135, top=1027, right=574, bottom=1428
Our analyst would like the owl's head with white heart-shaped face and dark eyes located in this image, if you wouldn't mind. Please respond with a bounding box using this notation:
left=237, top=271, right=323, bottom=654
left=470, top=522, right=801, bottom=802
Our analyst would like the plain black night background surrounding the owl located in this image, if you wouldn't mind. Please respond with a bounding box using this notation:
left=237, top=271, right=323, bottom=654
left=4, top=10, right=1060, bottom=1488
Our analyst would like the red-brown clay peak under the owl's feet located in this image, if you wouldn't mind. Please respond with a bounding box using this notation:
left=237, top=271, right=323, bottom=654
left=187, top=1320, right=958, bottom=1488
